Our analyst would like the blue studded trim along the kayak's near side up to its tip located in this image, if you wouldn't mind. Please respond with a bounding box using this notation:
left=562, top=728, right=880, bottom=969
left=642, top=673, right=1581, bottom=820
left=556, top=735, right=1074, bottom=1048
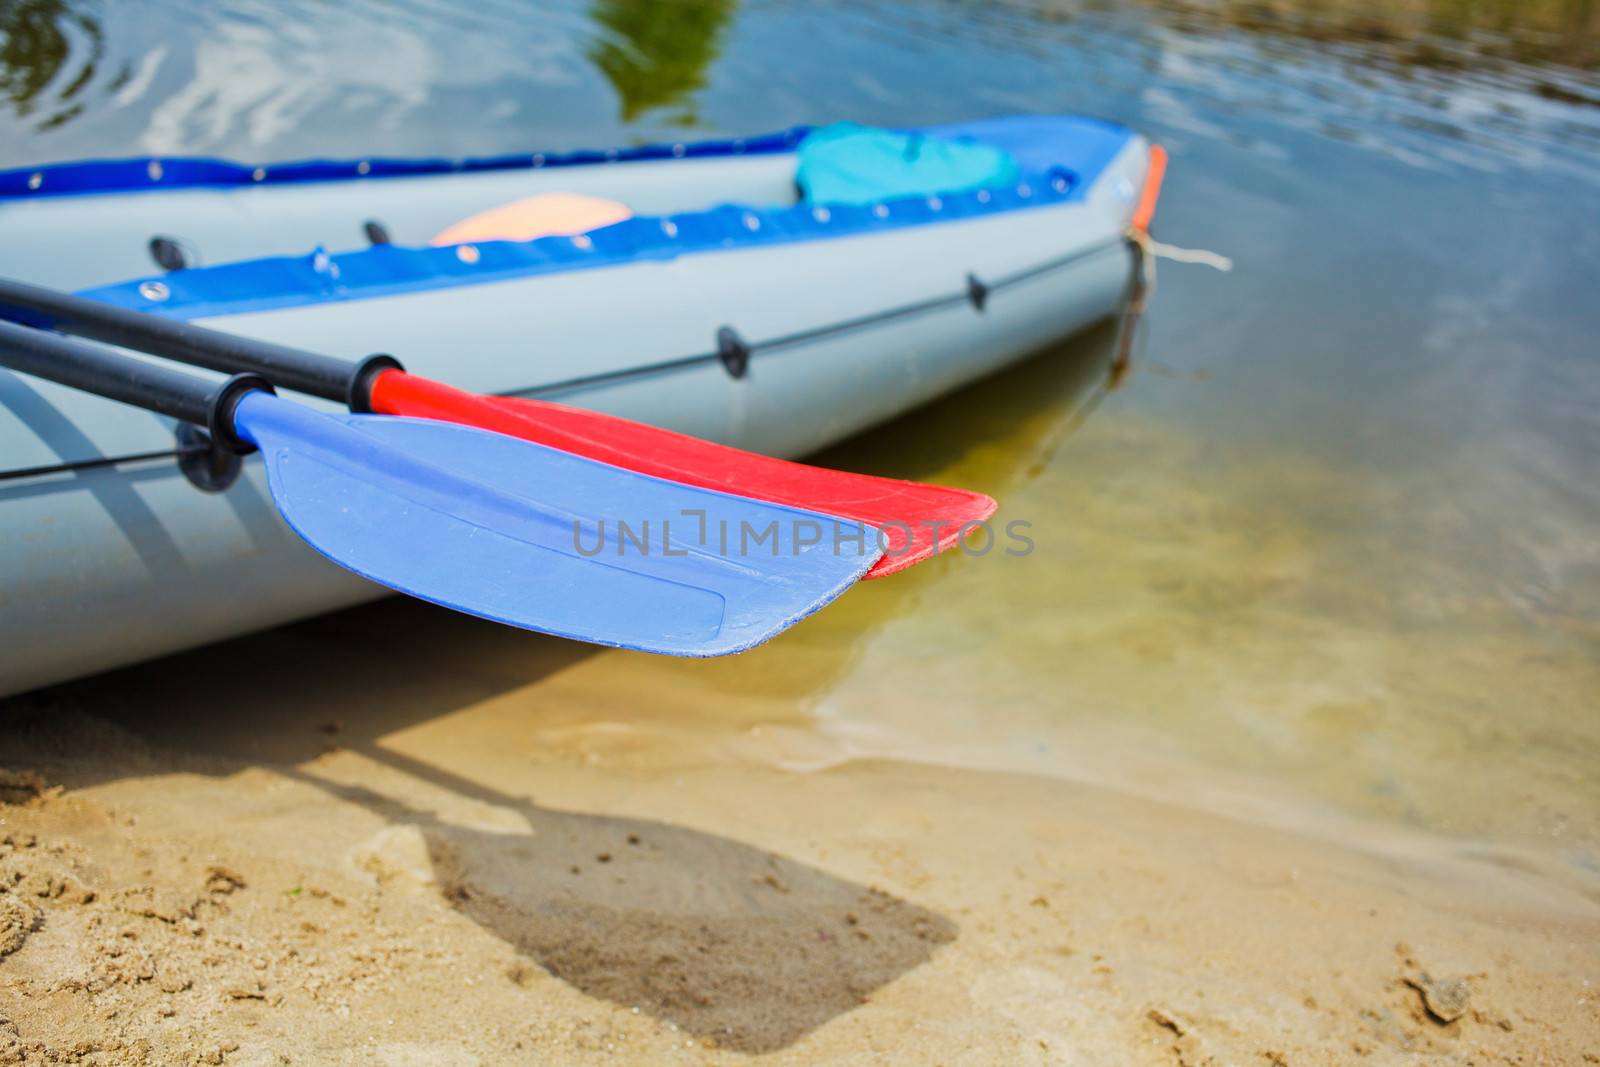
left=68, top=118, right=1133, bottom=318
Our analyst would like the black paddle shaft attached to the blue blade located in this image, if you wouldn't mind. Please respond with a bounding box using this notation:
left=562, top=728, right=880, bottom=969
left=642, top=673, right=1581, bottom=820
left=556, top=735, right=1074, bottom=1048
left=0, top=320, right=272, bottom=451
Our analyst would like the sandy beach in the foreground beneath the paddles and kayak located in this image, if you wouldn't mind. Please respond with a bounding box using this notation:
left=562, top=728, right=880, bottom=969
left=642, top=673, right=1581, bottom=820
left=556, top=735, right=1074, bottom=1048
left=0, top=601, right=1600, bottom=1065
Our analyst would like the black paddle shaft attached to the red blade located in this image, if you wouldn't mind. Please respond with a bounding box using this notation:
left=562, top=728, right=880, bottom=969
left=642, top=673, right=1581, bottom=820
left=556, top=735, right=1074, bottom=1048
left=0, top=278, right=405, bottom=411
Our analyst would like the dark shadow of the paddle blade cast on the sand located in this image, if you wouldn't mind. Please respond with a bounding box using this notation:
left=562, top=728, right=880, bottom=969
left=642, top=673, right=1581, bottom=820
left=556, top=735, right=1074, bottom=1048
left=302, top=750, right=957, bottom=1053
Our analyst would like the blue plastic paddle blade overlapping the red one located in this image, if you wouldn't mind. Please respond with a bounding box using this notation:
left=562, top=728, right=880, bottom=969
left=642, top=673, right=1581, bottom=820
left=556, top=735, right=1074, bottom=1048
left=234, top=392, right=882, bottom=656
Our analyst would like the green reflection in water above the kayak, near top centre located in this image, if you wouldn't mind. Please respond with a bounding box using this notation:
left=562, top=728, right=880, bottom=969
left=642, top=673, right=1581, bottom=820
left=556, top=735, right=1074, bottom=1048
left=589, top=0, right=739, bottom=126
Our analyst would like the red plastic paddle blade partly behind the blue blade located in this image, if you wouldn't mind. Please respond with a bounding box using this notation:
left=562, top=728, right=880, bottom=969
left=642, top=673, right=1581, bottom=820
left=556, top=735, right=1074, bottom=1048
left=371, top=371, right=995, bottom=577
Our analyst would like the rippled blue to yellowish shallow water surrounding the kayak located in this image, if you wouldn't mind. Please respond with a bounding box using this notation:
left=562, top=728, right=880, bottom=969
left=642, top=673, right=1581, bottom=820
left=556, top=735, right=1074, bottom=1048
left=0, top=0, right=1600, bottom=869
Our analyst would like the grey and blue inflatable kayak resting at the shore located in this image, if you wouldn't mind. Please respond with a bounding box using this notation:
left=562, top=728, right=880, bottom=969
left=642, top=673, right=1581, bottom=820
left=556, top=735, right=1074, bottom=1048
left=0, top=117, right=1152, bottom=694
